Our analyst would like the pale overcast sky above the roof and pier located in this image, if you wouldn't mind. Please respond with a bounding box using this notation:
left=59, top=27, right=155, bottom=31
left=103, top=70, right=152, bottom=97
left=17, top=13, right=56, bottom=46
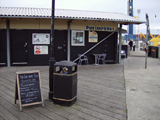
left=0, top=0, right=160, bottom=34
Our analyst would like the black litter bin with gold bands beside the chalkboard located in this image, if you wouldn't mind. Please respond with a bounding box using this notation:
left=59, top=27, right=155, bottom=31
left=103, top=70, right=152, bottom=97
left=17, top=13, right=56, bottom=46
left=53, top=61, right=77, bottom=106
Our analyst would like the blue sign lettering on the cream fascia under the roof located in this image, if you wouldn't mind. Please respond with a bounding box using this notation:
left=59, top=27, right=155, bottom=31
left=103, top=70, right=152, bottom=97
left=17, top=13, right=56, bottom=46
left=86, top=26, right=114, bottom=31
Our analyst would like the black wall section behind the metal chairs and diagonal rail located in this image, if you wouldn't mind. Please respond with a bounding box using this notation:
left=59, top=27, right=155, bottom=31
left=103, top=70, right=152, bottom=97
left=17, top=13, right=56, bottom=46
left=71, top=31, right=117, bottom=64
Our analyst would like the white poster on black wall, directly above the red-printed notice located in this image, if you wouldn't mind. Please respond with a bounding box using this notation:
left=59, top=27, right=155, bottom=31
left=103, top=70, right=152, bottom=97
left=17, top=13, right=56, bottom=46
left=32, top=33, right=50, bottom=44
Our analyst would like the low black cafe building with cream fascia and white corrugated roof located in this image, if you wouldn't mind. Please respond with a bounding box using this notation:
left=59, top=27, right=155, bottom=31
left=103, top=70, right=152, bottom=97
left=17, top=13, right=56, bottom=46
left=0, top=7, right=144, bottom=66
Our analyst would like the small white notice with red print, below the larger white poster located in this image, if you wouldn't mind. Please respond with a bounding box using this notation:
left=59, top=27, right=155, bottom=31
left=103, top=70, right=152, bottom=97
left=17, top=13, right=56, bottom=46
left=34, top=46, right=48, bottom=55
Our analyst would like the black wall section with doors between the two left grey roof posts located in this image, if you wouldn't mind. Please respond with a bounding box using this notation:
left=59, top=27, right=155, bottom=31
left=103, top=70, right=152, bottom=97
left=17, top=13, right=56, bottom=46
left=10, top=29, right=67, bottom=66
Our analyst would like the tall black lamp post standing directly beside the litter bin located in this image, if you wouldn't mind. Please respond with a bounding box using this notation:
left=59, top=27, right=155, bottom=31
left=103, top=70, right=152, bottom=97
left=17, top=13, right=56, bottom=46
left=49, top=0, right=55, bottom=100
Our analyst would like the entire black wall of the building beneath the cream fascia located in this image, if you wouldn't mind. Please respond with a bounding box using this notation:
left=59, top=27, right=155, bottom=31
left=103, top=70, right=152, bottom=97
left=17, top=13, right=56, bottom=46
left=0, top=29, right=117, bottom=66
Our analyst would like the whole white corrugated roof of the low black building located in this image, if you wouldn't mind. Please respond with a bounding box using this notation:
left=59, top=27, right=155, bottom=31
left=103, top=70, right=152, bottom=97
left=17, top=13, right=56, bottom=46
left=0, top=7, right=145, bottom=25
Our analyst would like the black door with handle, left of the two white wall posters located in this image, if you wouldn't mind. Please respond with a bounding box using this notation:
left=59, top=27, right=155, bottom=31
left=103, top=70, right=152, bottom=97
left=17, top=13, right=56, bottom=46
left=10, top=30, right=28, bottom=65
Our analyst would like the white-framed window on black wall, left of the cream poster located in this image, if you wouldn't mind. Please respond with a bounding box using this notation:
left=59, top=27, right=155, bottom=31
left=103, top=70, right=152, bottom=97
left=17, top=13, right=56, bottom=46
left=71, top=30, right=85, bottom=46
